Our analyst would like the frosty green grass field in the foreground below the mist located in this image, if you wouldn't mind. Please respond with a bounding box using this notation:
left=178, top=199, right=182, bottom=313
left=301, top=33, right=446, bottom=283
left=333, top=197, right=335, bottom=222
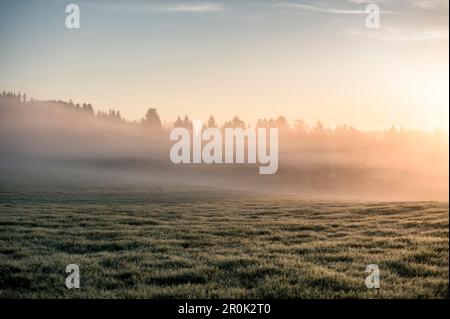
left=0, top=189, right=449, bottom=298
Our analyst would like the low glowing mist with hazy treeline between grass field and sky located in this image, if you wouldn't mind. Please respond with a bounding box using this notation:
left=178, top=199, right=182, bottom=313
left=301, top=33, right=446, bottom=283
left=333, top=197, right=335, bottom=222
left=0, top=94, right=449, bottom=200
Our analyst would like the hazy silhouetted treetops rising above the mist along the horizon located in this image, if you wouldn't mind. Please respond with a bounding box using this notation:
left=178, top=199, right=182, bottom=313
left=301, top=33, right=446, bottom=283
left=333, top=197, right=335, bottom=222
left=0, top=91, right=448, bottom=141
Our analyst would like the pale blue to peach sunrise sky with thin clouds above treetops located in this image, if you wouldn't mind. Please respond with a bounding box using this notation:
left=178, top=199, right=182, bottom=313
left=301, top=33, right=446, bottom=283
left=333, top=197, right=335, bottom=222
left=0, top=0, right=449, bottom=132
